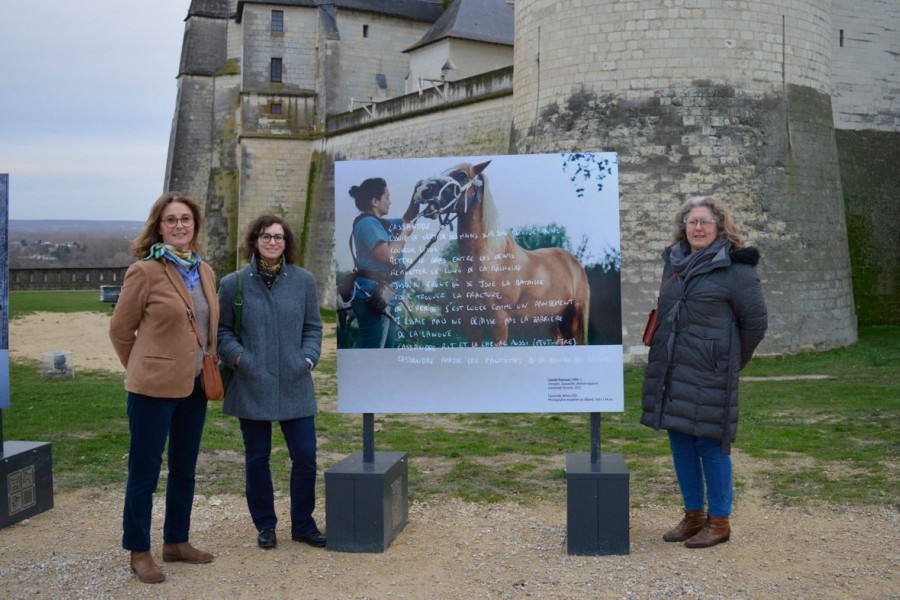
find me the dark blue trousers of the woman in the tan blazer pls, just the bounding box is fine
[122,377,206,552]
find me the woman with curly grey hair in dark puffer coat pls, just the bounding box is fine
[641,196,767,548]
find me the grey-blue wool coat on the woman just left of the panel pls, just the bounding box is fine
[218,259,322,421]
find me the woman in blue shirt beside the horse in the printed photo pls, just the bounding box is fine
[350,177,419,348]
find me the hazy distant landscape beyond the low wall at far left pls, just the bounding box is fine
[8,219,144,269]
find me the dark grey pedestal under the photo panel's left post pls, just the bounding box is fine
[325,452,409,552]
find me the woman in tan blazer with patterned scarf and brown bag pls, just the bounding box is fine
[109,192,219,583]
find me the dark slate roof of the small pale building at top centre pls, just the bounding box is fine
[404,0,515,52]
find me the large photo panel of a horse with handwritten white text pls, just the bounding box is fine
[335,153,624,413]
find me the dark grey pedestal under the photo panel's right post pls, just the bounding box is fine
[566,453,629,556]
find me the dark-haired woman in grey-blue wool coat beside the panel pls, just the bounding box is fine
[219,215,325,548]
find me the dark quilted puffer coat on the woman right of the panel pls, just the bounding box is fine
[641,245,768,454]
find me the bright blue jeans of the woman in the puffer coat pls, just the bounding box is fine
[669,430,734,517]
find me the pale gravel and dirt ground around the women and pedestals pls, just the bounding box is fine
[0,313,900,600]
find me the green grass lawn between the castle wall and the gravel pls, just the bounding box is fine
[3,292,900,507]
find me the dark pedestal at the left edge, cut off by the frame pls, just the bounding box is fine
[0,442,53,529]
